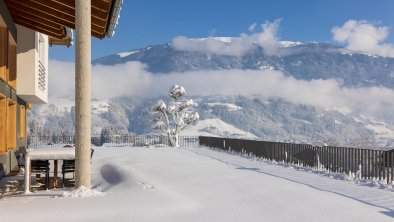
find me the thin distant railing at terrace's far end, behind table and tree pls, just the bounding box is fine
[27,135,199,148]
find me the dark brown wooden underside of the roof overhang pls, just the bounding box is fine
[5,0,112,39]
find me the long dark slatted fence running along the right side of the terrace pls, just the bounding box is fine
[199,136,394,184]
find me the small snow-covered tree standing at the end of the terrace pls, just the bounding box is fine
[153,85,200,147]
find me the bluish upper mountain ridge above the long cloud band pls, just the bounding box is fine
[93,38,394,88]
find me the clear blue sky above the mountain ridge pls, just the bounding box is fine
[49,0,394,61]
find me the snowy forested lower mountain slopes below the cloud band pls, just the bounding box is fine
[29,96,394,146]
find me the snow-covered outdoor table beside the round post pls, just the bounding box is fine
[25,147,75,193]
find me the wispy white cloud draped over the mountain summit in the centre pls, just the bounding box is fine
[172,19,281,57]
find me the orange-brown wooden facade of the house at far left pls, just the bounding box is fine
[0,1,27,177]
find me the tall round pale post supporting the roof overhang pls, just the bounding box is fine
[75,0,91,189]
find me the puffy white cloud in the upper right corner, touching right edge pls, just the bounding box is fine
[331,20,394,57]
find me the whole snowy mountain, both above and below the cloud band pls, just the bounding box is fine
[29,38,394,147]
